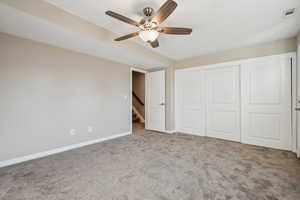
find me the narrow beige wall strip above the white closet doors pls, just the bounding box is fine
[176,38,297,69]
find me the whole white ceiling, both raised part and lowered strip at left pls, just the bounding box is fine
[0,0,300,69]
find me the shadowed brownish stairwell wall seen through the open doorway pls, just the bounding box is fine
[132,71,145,118]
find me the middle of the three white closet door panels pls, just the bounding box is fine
[205,66,241,142]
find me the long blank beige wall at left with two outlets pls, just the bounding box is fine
[0,33,131,161]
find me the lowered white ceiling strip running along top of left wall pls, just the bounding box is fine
[0,3,169,69]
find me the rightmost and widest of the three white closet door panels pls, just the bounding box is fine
[241,55,291,150]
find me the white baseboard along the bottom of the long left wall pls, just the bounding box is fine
[0,132,131,168]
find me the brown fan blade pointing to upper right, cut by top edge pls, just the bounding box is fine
[152,0,177,24]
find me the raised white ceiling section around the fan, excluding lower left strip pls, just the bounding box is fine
[47,0,300,60]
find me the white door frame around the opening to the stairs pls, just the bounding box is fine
[129,67,149,133]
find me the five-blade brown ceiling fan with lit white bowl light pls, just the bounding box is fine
[105,0,192,48]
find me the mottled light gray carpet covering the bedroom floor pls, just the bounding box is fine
[0,130,300,200]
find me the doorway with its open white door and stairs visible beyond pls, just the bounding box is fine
[130,68,166,135]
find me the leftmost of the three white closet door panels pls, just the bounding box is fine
[175,69,205,136]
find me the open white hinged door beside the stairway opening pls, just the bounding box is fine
[146,70,165,131]
